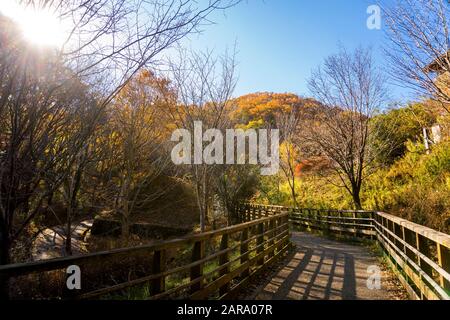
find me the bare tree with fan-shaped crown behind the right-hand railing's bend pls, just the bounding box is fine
[305,49,386,209]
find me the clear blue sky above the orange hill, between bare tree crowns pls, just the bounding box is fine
[184,0,412,100]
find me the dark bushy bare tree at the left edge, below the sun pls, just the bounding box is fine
[0,38,95,264]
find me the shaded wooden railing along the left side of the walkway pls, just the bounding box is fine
[0,212,290,299]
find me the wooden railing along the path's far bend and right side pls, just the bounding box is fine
[245,204,450,300]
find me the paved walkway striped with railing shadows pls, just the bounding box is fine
[249,232,393,300]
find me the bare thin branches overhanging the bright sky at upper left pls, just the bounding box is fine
[18,0,239,104]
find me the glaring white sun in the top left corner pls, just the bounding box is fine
[0,0,65,47]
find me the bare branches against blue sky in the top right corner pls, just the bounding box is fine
[383,0,450,112]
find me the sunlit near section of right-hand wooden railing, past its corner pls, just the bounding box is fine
[374,212,450,300]
